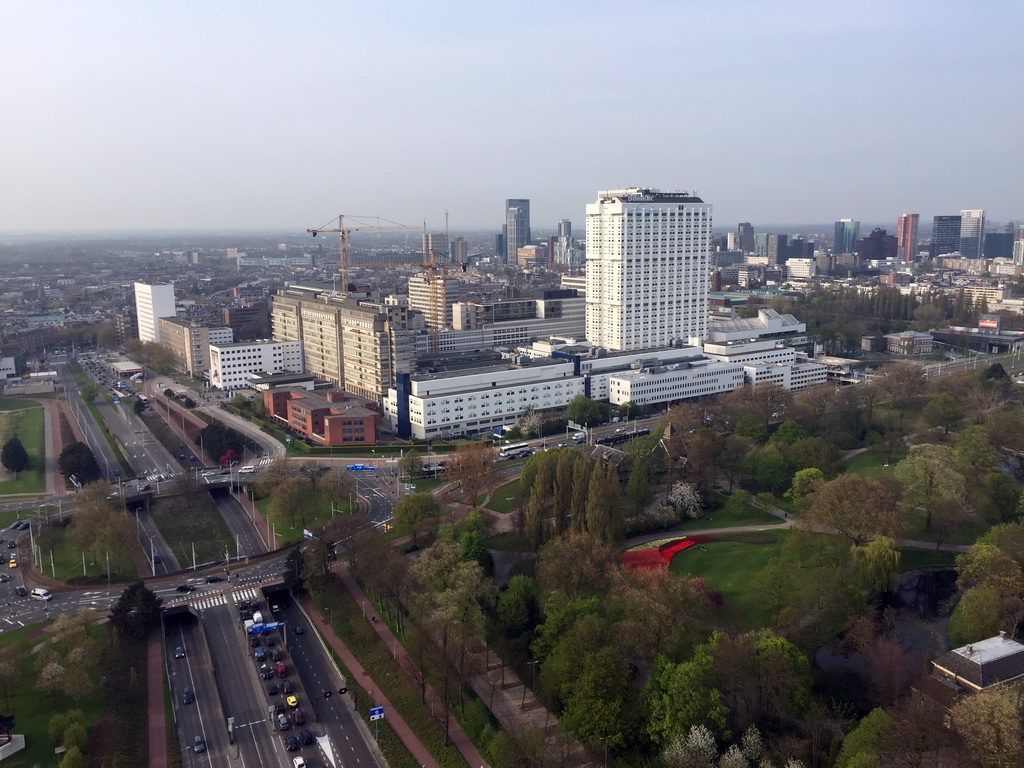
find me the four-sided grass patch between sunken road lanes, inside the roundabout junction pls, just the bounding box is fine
[151,490,234,568]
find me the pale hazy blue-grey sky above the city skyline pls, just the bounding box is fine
[0,0,1024,232]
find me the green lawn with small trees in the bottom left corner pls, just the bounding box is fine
[0,624,109,768]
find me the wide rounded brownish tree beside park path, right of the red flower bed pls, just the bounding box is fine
[802,474,904,547]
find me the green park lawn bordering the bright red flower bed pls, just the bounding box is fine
[669,530,790,632]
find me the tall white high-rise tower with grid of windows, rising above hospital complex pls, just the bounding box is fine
[587,187,712,350]
